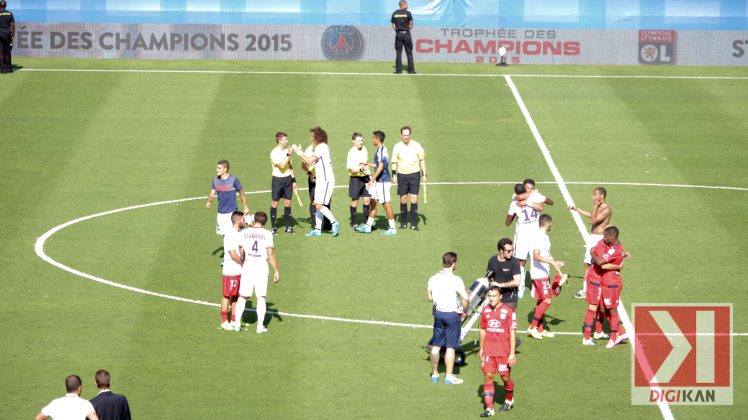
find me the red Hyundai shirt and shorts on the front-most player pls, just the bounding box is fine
[480,304,517,375]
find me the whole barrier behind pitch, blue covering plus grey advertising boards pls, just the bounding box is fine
[9,0,748,65]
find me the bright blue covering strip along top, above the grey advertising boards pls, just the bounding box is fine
[9,0,748,30]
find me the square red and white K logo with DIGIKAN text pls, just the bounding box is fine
[631,304,733,405]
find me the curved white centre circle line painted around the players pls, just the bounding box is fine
[34,181,748,337]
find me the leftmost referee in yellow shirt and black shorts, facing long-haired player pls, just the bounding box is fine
[270,131,297,235]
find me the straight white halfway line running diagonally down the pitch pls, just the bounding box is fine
[504,76,675,420]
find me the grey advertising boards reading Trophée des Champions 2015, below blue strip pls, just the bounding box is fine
[13,23,748,66]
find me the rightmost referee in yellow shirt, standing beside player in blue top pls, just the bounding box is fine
[392,126,428,230]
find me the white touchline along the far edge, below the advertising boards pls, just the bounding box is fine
[18,68,748,80]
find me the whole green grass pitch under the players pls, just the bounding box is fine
[0,58,748,419]
